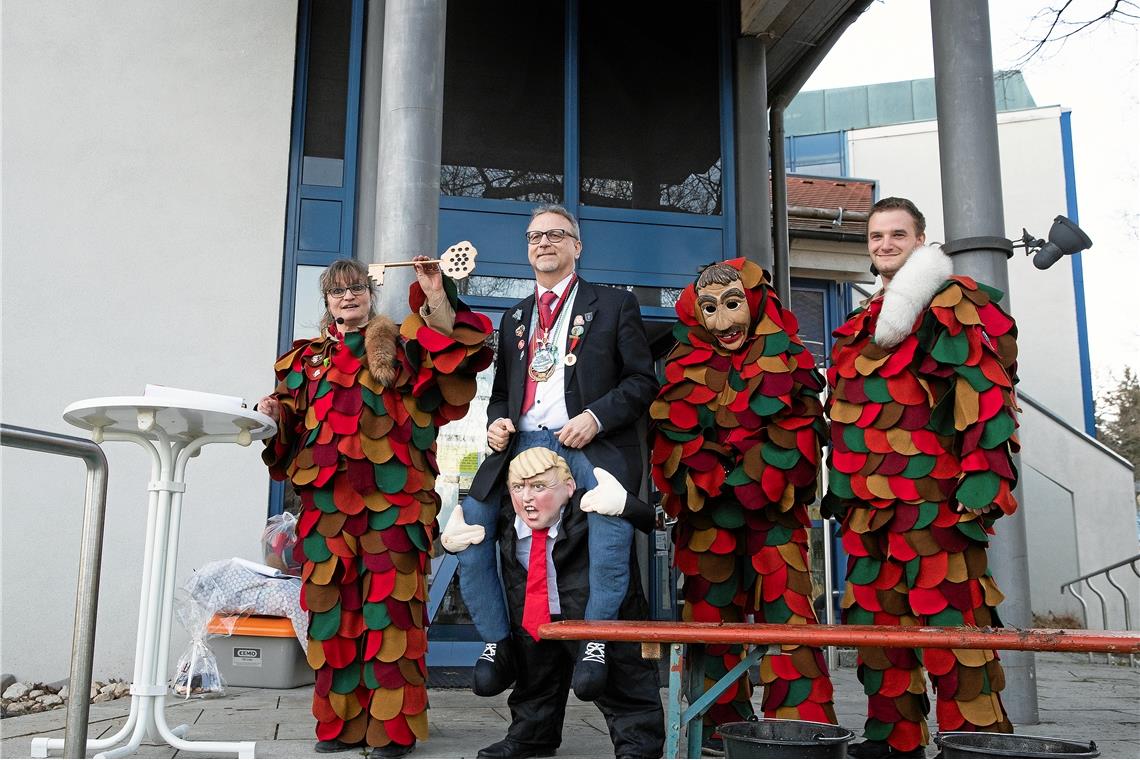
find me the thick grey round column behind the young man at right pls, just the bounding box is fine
[930,0,1039,725]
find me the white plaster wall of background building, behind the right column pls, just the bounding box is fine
[847,106,1084,430]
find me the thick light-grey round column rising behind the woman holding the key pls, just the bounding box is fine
[373,0,447,321]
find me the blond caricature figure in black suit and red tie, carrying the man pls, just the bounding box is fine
[465,447,665,758]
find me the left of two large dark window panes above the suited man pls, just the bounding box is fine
[440,0,565,202]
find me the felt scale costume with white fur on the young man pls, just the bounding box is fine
[824,248,1018,752]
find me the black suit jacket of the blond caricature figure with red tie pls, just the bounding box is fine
[498,489,653,628]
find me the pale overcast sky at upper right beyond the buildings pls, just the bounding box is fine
[804,0,1140,390]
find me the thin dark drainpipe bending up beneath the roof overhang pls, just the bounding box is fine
[768,0,871,308]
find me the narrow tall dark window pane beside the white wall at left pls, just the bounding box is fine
[301,0,352,187]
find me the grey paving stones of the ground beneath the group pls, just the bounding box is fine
[0,653,1140,760]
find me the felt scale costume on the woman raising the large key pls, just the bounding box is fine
[264,281,491,746]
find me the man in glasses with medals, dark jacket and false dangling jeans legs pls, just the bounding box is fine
[443,205,657,700]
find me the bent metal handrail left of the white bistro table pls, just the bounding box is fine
[0,423,107,758]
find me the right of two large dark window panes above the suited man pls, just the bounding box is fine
[579,2,720,214]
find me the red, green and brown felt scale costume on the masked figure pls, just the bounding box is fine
[650,259,836,735]
